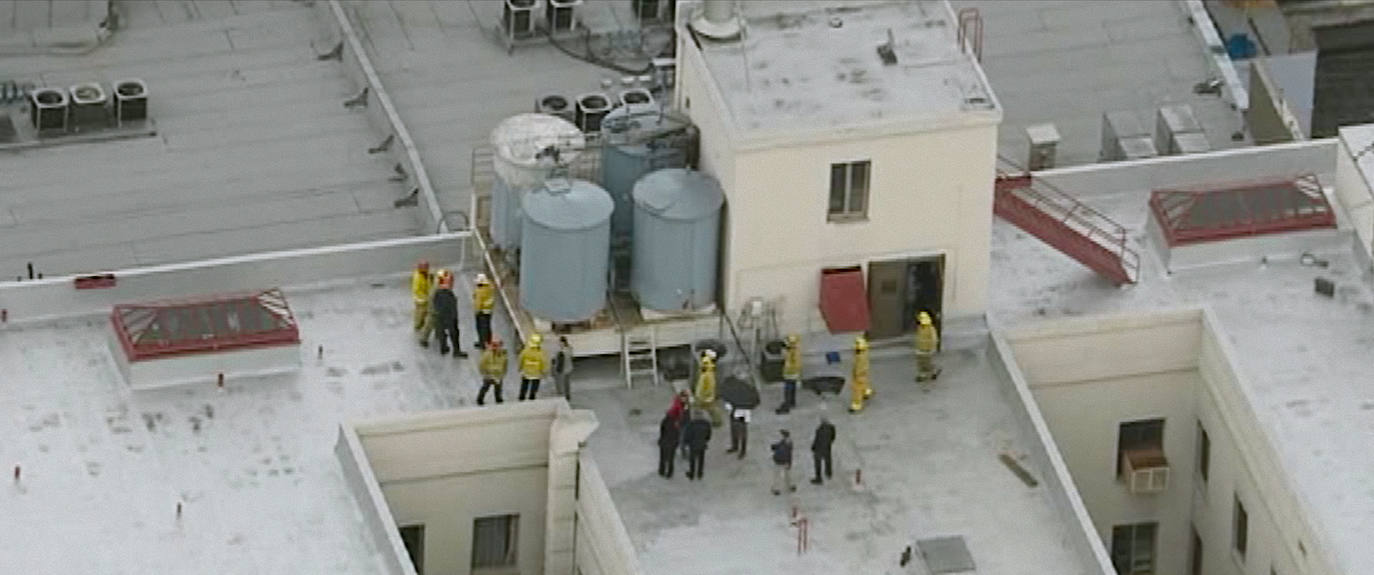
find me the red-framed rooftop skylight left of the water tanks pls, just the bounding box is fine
[110,289,301,362]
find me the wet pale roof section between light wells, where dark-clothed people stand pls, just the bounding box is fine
[585,351,1092,575]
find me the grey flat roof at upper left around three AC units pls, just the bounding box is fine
[0,0,416,279]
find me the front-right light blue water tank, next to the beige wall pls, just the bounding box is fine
[631,168,725,312]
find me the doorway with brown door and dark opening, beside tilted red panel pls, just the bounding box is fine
[868,254,944,338]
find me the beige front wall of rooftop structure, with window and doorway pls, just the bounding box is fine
[723,125,998,332]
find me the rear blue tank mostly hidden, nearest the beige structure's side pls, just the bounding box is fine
[602,103,687,241]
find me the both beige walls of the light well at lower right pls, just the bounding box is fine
[1004,310,1336,575]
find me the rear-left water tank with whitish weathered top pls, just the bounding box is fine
[491,114,587,252]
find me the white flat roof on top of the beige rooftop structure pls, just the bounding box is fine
[701,0,993,132]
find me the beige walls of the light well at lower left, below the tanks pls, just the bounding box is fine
[337,399,615,575]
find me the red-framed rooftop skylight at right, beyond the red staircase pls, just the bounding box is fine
[1150,173,1336,248]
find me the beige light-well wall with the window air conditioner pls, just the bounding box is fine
[1013,312,1201,575]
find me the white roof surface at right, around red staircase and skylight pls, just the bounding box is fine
[989,182,1374,574]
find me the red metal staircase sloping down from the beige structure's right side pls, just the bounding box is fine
[992,160,1140,286]
